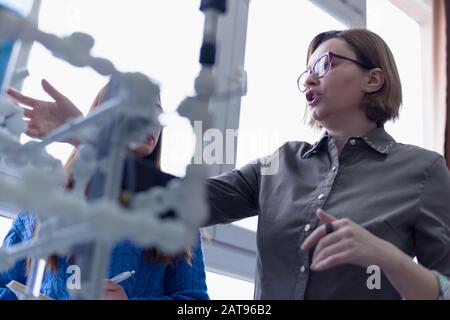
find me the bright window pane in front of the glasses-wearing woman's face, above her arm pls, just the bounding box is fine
[236,0,346,230]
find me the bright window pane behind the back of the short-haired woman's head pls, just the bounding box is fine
[367,0,427,147]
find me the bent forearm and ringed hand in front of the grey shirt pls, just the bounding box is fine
[302,209,439,299]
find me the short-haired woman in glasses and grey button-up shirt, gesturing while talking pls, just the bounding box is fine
[6,29,450,299]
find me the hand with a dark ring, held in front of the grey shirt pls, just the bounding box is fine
[302,209,392,271]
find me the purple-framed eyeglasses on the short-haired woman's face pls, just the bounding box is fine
[297,51,373,93]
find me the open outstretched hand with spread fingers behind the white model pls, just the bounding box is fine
[7,80,82,144]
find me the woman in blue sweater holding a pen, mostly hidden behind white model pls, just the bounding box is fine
[0,81,209,300]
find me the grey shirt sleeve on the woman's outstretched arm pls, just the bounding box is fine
[206,159,260,226]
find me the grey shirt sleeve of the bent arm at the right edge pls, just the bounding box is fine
[414,156,450,276]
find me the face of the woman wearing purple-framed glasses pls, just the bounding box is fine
[305,39,366,128]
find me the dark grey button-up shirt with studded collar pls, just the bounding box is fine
[208,128,450,299]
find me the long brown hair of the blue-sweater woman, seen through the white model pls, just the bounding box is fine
[32,85,192,272]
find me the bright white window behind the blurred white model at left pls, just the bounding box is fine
[23,0,204,176]
